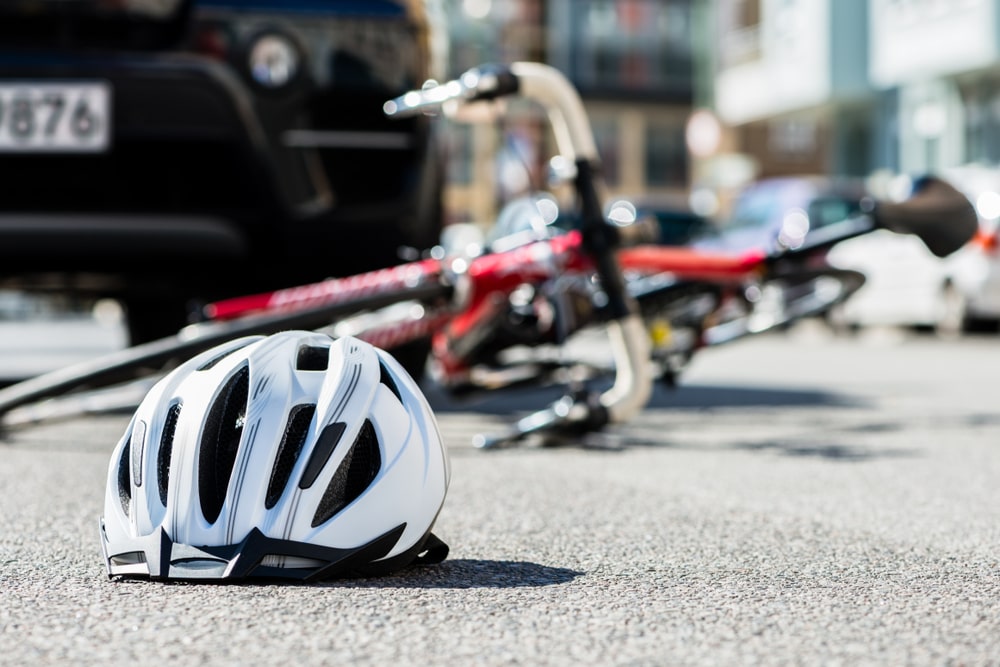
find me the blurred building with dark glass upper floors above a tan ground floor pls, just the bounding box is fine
[548,0,693,193]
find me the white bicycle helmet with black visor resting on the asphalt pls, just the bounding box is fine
[101,331,450,581]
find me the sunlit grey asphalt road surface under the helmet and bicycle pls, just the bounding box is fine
[0,328,1000,665]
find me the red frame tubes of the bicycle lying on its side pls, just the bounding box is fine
[204,231,766,377]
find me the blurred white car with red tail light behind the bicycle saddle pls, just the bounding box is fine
[827,172,1000,335]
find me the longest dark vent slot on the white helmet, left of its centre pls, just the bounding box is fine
[198,365,250,523]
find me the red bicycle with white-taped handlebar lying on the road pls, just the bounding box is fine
[0,63,975,447]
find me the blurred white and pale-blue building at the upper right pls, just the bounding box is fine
[710,0,1000,192]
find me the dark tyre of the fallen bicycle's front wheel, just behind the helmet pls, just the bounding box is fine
[0,283,451,426]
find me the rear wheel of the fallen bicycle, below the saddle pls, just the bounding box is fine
[702,268,865,345]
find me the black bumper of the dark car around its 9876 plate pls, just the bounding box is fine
[0,50,442,282]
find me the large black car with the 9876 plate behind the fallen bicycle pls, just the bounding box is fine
[0,0,447,342]
